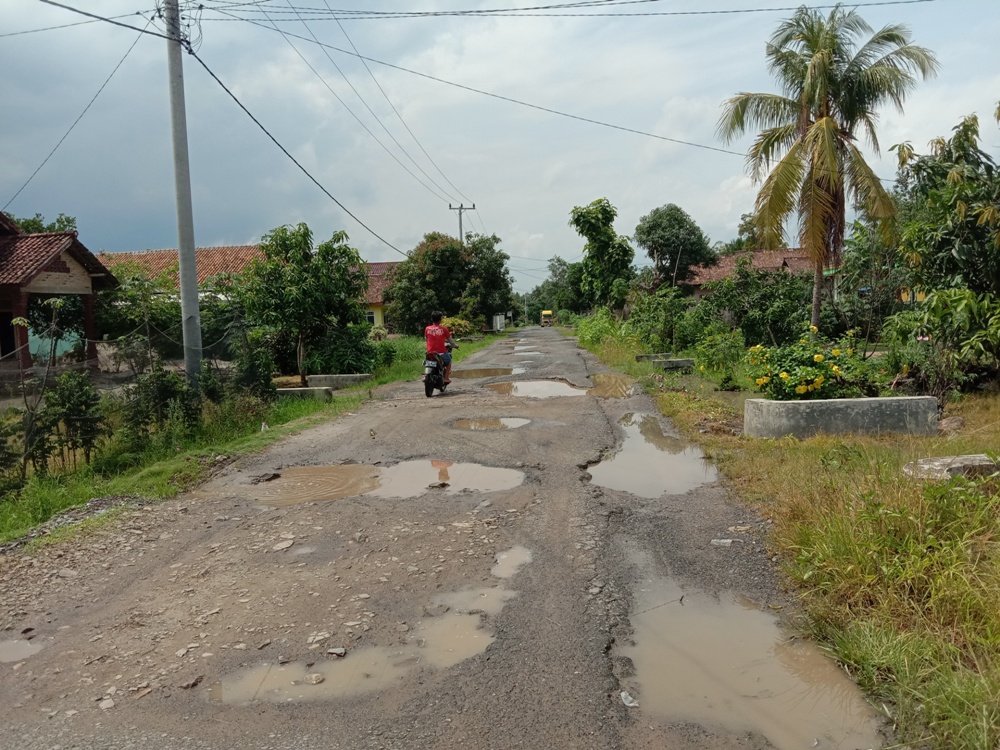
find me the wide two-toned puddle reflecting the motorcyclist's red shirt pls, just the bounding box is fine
[251,460,524,507]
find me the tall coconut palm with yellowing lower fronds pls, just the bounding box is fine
[718,5,937,326]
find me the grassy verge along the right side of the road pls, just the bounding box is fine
[593,334,1000,750]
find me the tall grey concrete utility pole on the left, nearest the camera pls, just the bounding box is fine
[163,0,201,386]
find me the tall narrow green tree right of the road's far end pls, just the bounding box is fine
[569,198,635,308]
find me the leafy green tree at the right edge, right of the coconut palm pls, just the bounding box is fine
[895,115,1000,295]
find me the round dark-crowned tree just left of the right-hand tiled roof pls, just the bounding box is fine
[633,203,718,286]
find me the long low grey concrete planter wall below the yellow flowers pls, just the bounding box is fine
[743,396,938,438]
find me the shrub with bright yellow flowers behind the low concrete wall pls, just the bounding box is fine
[746,326,884,401]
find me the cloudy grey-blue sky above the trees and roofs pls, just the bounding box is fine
[0,0,1000,291]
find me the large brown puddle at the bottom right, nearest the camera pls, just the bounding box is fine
[623,580,883,750]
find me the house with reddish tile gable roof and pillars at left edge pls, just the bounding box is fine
[0,212,118,371]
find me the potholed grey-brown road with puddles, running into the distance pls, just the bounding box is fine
[0,329,892,750]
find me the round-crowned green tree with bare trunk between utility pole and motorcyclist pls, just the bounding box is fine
[240,223,368,386]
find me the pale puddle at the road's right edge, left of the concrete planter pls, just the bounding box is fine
[588,414,717,498]
